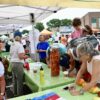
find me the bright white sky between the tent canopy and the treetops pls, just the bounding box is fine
[42,8,100,26]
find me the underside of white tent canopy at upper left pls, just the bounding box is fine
[0,5,61,31]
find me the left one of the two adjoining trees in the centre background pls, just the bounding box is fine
[47,19,61,28]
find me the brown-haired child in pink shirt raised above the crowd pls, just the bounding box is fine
[71,18,82,39]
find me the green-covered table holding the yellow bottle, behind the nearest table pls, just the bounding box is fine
[24,63,75,92]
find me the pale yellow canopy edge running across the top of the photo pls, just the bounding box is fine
[0,0,100,8]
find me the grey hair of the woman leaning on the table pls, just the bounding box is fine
[77,42,99,57]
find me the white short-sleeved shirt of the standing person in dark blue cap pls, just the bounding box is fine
[10,41,25,63]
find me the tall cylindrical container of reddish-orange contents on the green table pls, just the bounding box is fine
[50,48,60,76]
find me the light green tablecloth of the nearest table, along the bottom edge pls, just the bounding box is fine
[9,85,97,100]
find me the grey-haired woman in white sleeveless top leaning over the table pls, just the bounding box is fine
[72,42,100,95]
